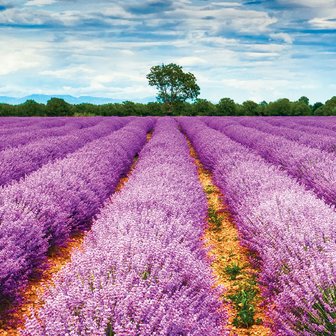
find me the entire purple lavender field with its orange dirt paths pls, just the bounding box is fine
[0,117,336,336]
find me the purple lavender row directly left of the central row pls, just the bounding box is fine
[0,119,153,301]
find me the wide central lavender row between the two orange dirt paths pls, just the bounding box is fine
[24,119,227,336]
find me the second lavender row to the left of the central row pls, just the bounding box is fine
[0,118,127,185]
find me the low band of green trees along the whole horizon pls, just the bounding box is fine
[0,96,336,116]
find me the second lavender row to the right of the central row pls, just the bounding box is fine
[205,117,336,205]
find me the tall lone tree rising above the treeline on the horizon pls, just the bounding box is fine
[147,63,200,113]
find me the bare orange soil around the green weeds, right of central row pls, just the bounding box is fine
[188,141,272,336]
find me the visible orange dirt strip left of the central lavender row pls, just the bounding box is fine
[0,132,152,336]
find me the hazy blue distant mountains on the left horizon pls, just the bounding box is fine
[0,94,155,105]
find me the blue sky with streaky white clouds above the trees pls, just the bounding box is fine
[0,0,336,102]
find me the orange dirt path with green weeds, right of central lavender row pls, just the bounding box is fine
[188,140,272,336]
